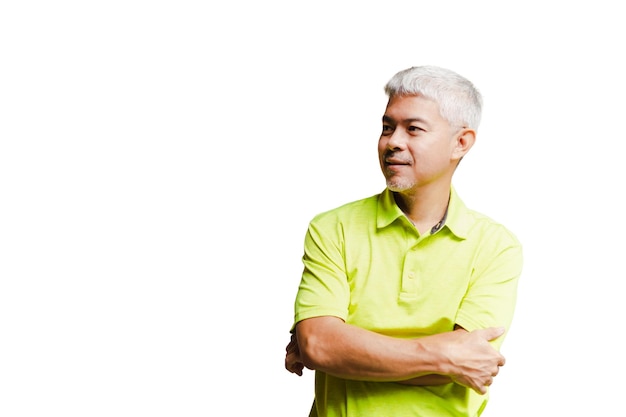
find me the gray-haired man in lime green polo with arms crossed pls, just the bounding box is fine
[285,66,522,417]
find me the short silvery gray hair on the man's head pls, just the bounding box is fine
[385,66,482,130]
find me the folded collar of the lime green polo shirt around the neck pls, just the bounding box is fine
[376,187,471,239]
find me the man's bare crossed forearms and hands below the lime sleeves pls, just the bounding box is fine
[285,316,505,394]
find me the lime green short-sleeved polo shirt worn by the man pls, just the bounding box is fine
[294,189,522,417]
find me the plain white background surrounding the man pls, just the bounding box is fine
[0,1,626,417]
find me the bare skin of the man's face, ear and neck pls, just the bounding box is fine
[378,92,476,233]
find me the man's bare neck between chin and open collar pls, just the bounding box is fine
[393,184,450,233]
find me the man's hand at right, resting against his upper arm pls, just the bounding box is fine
[436,327,505,394]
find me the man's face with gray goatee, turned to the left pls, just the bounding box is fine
[378,96,471,192]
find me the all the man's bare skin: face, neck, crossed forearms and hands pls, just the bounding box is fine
[285,96,505,394]
